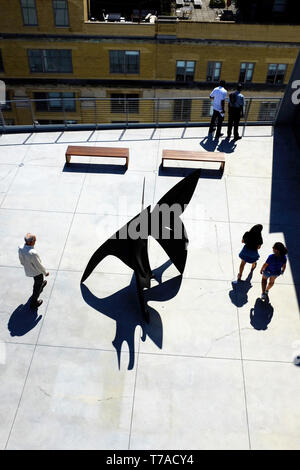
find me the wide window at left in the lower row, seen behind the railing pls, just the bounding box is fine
[33,92,76,112]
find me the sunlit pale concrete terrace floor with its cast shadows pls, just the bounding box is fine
[0,127,300,450]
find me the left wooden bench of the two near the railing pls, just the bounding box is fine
[66,145,129,169]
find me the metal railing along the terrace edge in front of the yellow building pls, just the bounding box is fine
[0,96,281,133]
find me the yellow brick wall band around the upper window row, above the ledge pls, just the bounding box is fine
[1,40,298,83]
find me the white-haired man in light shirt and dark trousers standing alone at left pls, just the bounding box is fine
[19,233,49,308]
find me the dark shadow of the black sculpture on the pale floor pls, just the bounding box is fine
[80,260,182,370]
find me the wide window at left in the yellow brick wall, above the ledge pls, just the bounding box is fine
[28,49,72,73]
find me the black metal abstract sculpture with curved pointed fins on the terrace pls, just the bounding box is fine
[81,170,201,323]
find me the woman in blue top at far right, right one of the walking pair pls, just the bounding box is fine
[260,242,288,299]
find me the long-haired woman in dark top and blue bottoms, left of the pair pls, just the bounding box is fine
[237,224,263,281]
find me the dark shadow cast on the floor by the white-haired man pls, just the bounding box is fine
[7,297,42,336]
